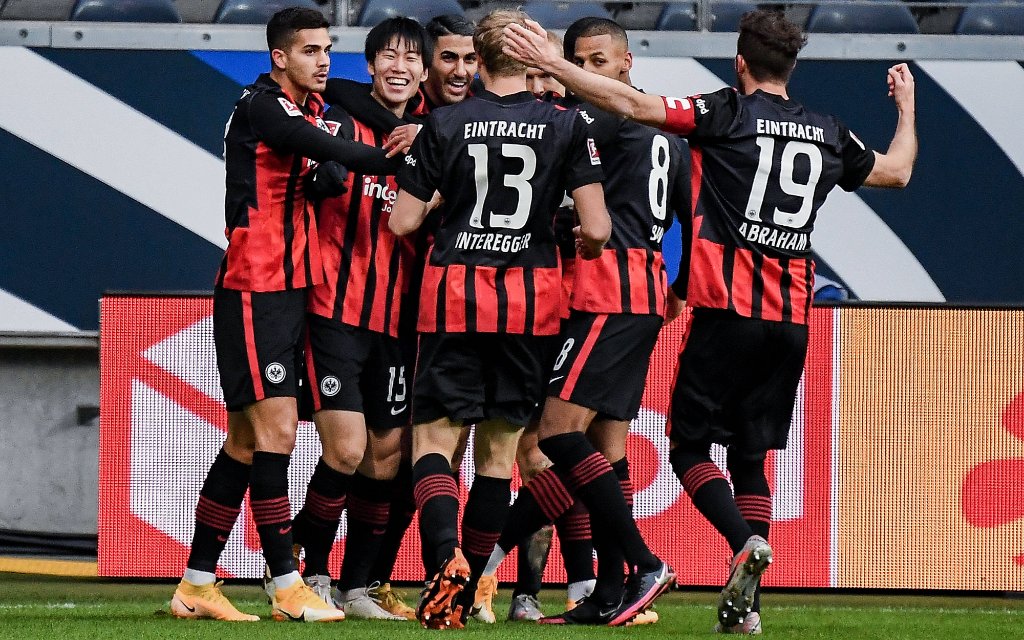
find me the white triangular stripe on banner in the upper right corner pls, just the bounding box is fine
[918,60,1024,174]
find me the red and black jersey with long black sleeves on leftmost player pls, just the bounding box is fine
[216,74,401,291]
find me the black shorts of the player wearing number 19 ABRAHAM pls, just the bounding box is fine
[669,309,807,458]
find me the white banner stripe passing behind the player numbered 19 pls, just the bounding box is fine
[632,57,942,301]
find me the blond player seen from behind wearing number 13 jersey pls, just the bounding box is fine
[390,11,610,628]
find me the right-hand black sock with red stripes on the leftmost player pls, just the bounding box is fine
[249,452,295,578]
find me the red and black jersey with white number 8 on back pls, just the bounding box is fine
[561,93,689,315]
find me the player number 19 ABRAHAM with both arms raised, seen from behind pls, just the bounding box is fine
[506,10,918,633]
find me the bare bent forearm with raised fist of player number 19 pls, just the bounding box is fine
[864,62,918,188]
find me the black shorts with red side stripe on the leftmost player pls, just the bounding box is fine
[213,287,306,412]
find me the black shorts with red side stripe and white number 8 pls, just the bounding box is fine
[548,309,665,421]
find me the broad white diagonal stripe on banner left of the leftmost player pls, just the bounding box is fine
[0,47,227,248]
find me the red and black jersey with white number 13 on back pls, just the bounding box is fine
[398,91,603,335]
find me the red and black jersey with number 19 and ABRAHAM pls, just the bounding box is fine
[664,88,874,324]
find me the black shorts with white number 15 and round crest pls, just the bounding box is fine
[306,313,413,429]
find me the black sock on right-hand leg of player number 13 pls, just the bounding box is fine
[462,475,512,605]
